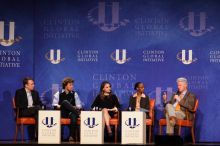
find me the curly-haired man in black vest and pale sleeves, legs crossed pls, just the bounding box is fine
[52,77,82,141]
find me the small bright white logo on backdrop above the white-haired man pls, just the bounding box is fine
[176,50,198,65]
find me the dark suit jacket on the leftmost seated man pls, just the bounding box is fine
[15,88,42,109]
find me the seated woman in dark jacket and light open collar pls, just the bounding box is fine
[129,82,150,118]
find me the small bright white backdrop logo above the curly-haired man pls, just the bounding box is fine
[45,49,65,64]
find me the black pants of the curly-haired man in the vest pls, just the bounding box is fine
[61,100,79,138]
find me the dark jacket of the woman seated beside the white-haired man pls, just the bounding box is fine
[129,94,150,118]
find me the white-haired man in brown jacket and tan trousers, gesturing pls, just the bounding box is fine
[163,77,196,135]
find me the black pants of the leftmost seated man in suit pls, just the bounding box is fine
[19,106,41,138]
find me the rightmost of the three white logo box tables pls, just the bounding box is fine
[121,111,146,144]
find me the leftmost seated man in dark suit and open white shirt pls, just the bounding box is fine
[15,77,43,139]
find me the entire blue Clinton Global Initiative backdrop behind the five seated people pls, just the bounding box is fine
[0,0,220,142]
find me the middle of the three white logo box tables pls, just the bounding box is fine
[80,111,105,144]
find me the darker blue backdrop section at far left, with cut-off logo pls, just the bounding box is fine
[0,0,34,140]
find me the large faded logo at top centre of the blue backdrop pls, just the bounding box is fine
[88,2,130,32]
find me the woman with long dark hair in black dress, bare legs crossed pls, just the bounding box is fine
[91,81,119,136]
